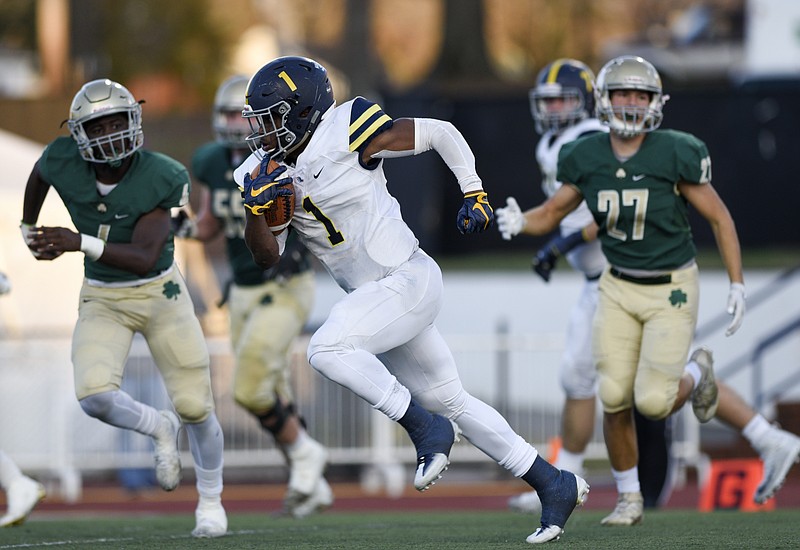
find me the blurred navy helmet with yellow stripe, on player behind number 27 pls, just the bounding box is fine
[528,59,594,134]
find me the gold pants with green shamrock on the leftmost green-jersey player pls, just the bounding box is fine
[72,266,214,422]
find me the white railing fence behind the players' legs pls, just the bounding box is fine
[0,332,699,501]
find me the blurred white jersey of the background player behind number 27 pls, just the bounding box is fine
[536,118,608,233]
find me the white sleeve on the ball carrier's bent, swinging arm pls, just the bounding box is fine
[414,118,483,194]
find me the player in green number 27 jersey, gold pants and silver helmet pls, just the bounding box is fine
[498,56,800,526]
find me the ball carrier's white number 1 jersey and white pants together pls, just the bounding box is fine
[234,97,537,477]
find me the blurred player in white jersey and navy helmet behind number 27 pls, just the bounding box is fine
[495,59,669,514]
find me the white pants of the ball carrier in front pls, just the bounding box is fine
[308,250,537,477]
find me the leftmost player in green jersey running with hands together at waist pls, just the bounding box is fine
[21,79,228,538]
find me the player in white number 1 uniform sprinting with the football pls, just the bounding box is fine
[234,57,589,543]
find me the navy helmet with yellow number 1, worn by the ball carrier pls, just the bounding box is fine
[242,56,335,158]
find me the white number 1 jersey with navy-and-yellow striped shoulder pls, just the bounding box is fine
[234,101,419,293]
